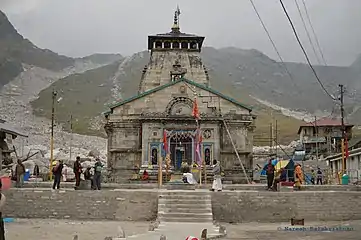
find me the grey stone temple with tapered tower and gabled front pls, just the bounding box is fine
[105,9,255,182]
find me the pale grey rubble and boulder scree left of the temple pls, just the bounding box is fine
[0,65,106,172]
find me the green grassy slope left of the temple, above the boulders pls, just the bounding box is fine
[31,61,119,134]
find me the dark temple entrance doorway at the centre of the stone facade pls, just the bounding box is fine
[170,131,194,170]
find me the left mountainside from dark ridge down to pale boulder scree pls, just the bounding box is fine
[0,9,123,168]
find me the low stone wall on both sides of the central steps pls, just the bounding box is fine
[2,186,361,222]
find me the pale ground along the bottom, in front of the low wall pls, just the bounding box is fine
[6,219,361,240]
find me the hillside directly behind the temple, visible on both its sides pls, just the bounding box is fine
[32,48,359,144]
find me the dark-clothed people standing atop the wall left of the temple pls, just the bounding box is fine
[52,156,103,190]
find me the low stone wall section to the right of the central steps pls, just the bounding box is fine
[212,191,361,225]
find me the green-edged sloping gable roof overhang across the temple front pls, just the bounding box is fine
[103,78,252,116]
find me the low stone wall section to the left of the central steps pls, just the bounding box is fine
[2,188,158,221]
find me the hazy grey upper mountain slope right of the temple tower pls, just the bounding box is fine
[203,48,356,112]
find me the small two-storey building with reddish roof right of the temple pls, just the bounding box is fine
[298,118,353,155]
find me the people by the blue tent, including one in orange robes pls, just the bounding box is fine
[266,159,304,191]
